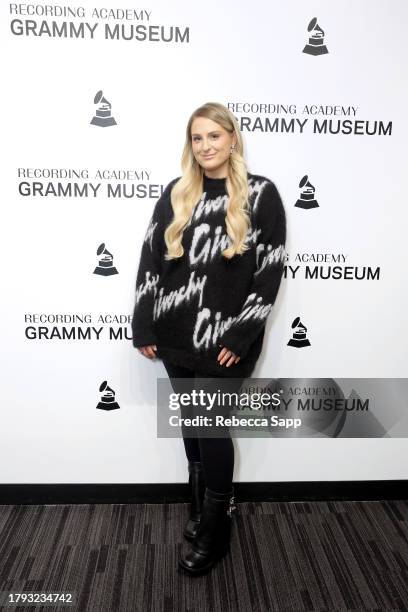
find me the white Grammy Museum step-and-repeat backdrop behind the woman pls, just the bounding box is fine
[0,0,408,483]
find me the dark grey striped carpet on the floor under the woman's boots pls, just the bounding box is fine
[0,501,408,612]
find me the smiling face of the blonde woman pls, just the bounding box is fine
[191,117,236,178]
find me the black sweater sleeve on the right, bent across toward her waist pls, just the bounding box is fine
[218,180,286,359]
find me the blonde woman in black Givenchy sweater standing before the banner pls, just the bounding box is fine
[132,103,286,575]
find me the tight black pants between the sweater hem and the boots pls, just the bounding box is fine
[163,360,244,493]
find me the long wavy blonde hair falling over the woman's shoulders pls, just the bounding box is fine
[164,102,250,260]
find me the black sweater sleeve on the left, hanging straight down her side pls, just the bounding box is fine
[132,179,178,348]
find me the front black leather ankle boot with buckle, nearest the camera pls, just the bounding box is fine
[179,488,235,576]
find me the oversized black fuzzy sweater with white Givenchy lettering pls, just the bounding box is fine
[132,173,286,377]
